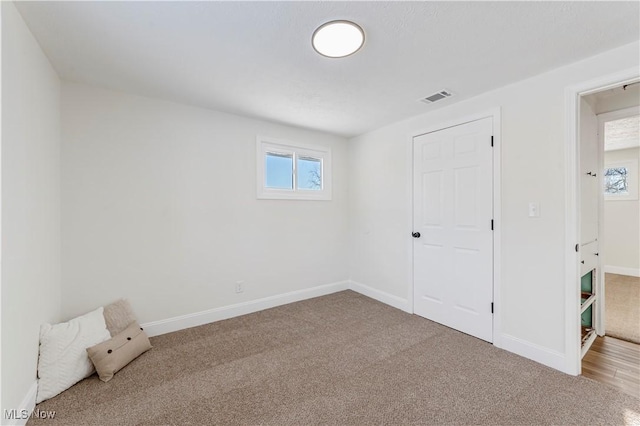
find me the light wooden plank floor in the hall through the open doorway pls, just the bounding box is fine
[582,336,640,398]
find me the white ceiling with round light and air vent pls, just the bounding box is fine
[17,1,640,136]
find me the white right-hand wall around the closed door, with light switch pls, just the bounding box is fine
[349,42,640,368]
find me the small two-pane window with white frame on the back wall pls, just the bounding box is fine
[257,136,331,200]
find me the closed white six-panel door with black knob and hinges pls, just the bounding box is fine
[413,118,493,342]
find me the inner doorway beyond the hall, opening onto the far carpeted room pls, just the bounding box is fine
[596,88,640,344]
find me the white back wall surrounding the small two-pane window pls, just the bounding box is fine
[62,83,348,322]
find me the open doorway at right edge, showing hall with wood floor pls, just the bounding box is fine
[579,81,640,395]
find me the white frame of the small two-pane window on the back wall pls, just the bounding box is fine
[256,136,332,200]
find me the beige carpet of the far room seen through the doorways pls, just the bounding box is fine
[604,274,640,343]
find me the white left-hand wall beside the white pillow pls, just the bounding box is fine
[1,2,60,413]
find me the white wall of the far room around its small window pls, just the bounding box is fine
[604,148,640,273]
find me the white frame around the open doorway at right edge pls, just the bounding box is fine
[564,68,640,375]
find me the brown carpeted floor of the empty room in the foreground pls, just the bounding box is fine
[29,291,640,425]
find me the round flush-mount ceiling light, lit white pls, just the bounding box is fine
[311,21,364,58]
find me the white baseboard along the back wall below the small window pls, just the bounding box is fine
[141,281,349,336]
